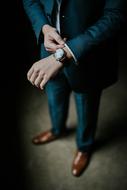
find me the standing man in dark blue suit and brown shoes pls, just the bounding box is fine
[23,0,125,176]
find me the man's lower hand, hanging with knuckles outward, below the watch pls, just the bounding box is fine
[27,55,63,89]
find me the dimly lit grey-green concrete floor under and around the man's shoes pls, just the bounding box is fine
[18,42,127,190]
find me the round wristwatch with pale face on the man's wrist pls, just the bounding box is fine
[53,48,66,63]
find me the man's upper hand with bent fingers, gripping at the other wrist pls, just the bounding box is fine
[42,24,65,53]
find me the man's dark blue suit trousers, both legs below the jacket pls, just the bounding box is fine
[46,72,101,151]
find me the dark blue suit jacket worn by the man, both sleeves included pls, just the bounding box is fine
[23,0,126,92]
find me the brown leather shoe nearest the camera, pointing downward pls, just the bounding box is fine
[72,151,90,177]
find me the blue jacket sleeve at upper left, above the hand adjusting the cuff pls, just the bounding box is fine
[23,0,49,42]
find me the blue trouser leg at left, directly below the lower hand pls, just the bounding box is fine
[46,72,71,135]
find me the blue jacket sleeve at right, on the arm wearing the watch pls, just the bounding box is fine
[66,0,126,61]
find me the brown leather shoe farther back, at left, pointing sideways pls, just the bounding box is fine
[32,130,58,145]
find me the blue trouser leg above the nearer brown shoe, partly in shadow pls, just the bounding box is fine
[75,90,101,151]
